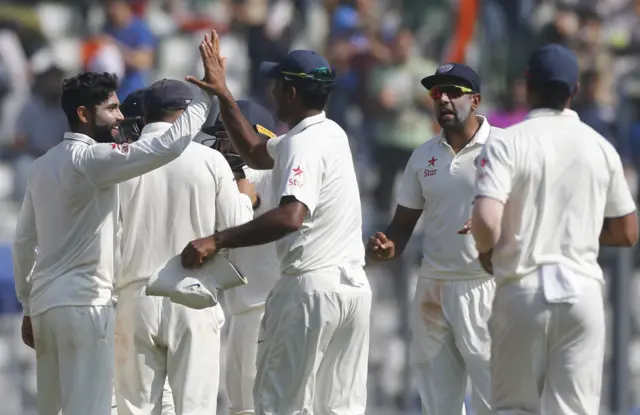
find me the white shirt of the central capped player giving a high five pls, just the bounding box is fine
[267,112,364,276]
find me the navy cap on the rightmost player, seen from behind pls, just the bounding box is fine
[527,43,580,91]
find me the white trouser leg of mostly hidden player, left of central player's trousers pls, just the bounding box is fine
[226,306,264,415]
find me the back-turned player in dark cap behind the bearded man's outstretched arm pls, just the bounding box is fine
[115,79,255,415]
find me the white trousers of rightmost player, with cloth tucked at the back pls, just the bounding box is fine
[490,273,605,415]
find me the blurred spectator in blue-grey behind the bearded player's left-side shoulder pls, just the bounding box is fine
[13,66,69,201]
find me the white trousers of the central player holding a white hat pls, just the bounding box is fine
[253,268,371,415]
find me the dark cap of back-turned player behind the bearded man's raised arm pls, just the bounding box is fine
[142,79,193,114]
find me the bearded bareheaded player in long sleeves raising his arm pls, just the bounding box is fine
[14,36,218,415]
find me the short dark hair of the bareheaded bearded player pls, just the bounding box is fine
[60,72,118,127]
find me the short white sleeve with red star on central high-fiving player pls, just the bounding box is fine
[275,137,324,214]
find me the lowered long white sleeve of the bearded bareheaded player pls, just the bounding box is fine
[13,185,38,316]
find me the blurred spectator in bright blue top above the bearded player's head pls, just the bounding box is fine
[103,0,156,101]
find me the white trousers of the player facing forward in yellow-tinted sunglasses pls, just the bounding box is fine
[410,278,495,415]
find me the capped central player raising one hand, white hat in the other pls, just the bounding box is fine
[182,31,371,415]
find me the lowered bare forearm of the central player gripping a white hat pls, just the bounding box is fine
[214,207,300,249]
